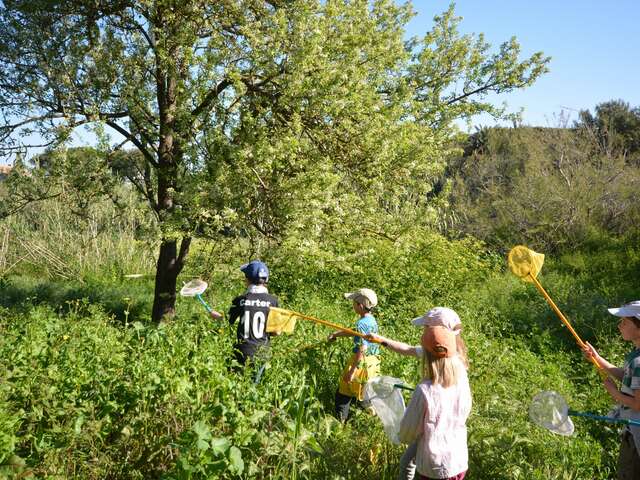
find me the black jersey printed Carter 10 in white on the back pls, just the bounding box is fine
[229,286,278,355]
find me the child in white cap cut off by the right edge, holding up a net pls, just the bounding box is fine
[583,300,640,480]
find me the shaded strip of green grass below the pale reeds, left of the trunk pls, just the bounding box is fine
[0,277,153,323]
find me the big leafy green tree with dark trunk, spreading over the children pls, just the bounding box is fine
[0,0,548,321]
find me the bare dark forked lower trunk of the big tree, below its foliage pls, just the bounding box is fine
[151,237,191,323]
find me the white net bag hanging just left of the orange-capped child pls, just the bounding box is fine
[364,376,405,445]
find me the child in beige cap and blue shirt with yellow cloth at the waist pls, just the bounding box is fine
[328,288,380,422]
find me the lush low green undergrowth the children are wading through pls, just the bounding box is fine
[0,232,638,480]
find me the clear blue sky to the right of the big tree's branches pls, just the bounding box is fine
[407,0,640,126]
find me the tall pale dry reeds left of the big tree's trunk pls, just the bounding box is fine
[0,189,156,281]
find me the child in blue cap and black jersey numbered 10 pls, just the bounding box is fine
[211,260,278,365]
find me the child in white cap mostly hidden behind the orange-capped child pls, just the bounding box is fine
[370,307,469,480]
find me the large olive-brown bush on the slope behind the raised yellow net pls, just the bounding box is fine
[448,127,640,252]
